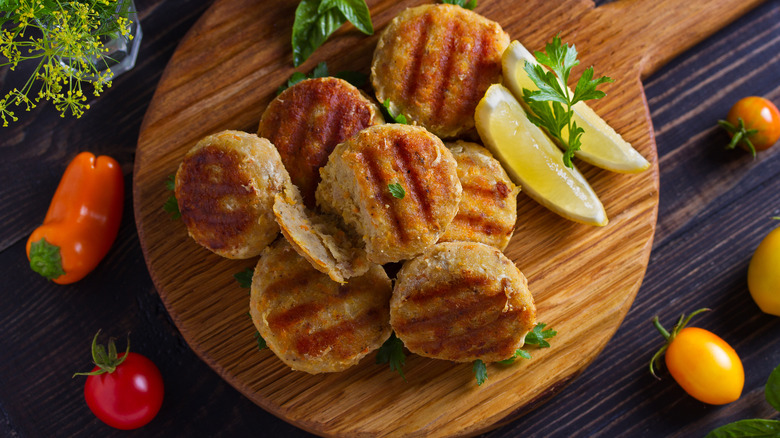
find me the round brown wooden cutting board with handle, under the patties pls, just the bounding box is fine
[133,0,760,437]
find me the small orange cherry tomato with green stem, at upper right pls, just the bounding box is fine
[721,96,780,151]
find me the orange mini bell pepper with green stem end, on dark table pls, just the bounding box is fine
[27,152,125,284]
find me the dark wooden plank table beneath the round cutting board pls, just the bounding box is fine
[0,0,780,437]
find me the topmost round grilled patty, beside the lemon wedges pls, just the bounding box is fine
[371,4,509,138]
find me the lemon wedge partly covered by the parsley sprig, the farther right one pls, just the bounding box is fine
[502,41,650,173]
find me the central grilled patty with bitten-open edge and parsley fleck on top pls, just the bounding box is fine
[316,124,461,264]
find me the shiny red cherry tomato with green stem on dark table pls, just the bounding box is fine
[76,332,164,430]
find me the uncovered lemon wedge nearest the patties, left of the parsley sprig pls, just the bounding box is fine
[474,84,607,226]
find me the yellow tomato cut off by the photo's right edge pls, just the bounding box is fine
[748,228,780,316]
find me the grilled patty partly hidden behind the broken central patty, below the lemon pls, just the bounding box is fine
[439,141,520,250]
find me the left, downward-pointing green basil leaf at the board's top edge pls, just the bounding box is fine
[292,0,347,67]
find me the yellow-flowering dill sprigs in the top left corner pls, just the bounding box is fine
[0,0,134,126]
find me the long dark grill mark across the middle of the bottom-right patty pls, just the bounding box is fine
[394,289,511,333]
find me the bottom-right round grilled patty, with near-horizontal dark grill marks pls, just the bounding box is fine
[390,242,536,362]
